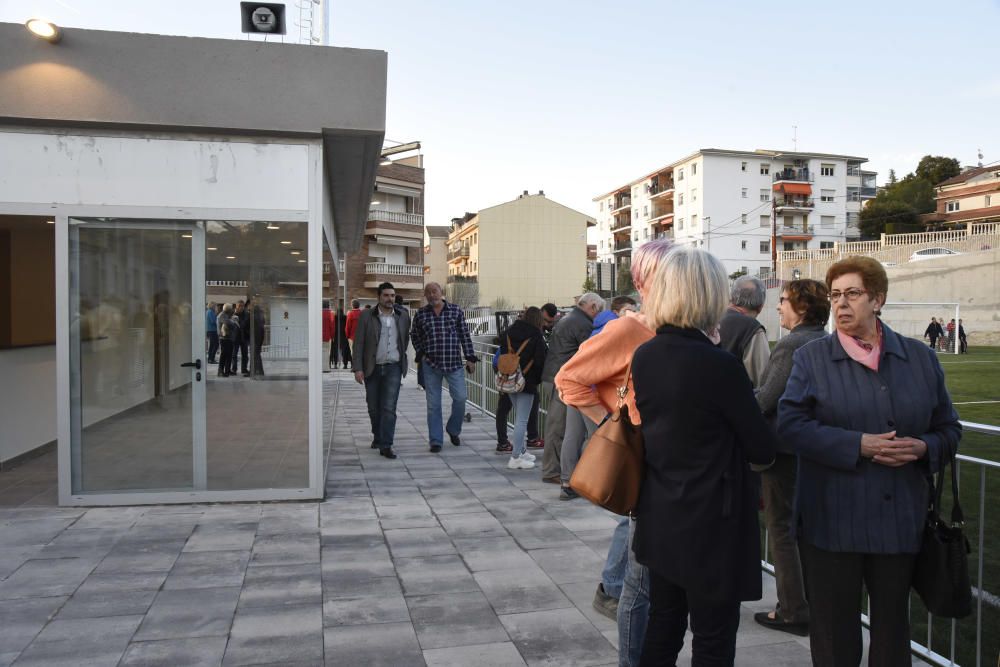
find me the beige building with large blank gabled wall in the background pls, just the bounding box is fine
[447,190,595,308]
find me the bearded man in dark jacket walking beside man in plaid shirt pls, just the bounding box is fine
[352,283,410,459]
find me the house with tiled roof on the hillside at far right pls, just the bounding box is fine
[921,165,1000,229]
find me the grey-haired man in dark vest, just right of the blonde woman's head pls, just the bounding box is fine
[719,276,771,388]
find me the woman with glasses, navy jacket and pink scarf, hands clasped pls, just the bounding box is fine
[778,257,961,667]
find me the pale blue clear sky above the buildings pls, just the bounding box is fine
[0,0,1000,225]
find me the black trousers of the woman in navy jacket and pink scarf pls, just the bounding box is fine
[799,540,916,667]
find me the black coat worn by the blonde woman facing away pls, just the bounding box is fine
[632,325,775,604]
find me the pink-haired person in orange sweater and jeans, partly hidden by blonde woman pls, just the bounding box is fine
[555,239,674,665]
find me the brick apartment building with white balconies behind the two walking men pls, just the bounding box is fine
[332,155,425,305]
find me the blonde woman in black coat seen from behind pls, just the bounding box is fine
[632,248,775,665]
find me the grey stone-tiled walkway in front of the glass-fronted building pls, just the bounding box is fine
[0,372,809,667]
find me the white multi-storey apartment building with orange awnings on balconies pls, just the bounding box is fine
[591,148,876,275]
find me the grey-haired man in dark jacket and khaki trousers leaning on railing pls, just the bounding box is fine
[542,292,604,490]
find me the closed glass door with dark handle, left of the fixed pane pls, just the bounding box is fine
[69,219,207,495]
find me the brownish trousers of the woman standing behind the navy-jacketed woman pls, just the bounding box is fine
[760,453,809,623]
